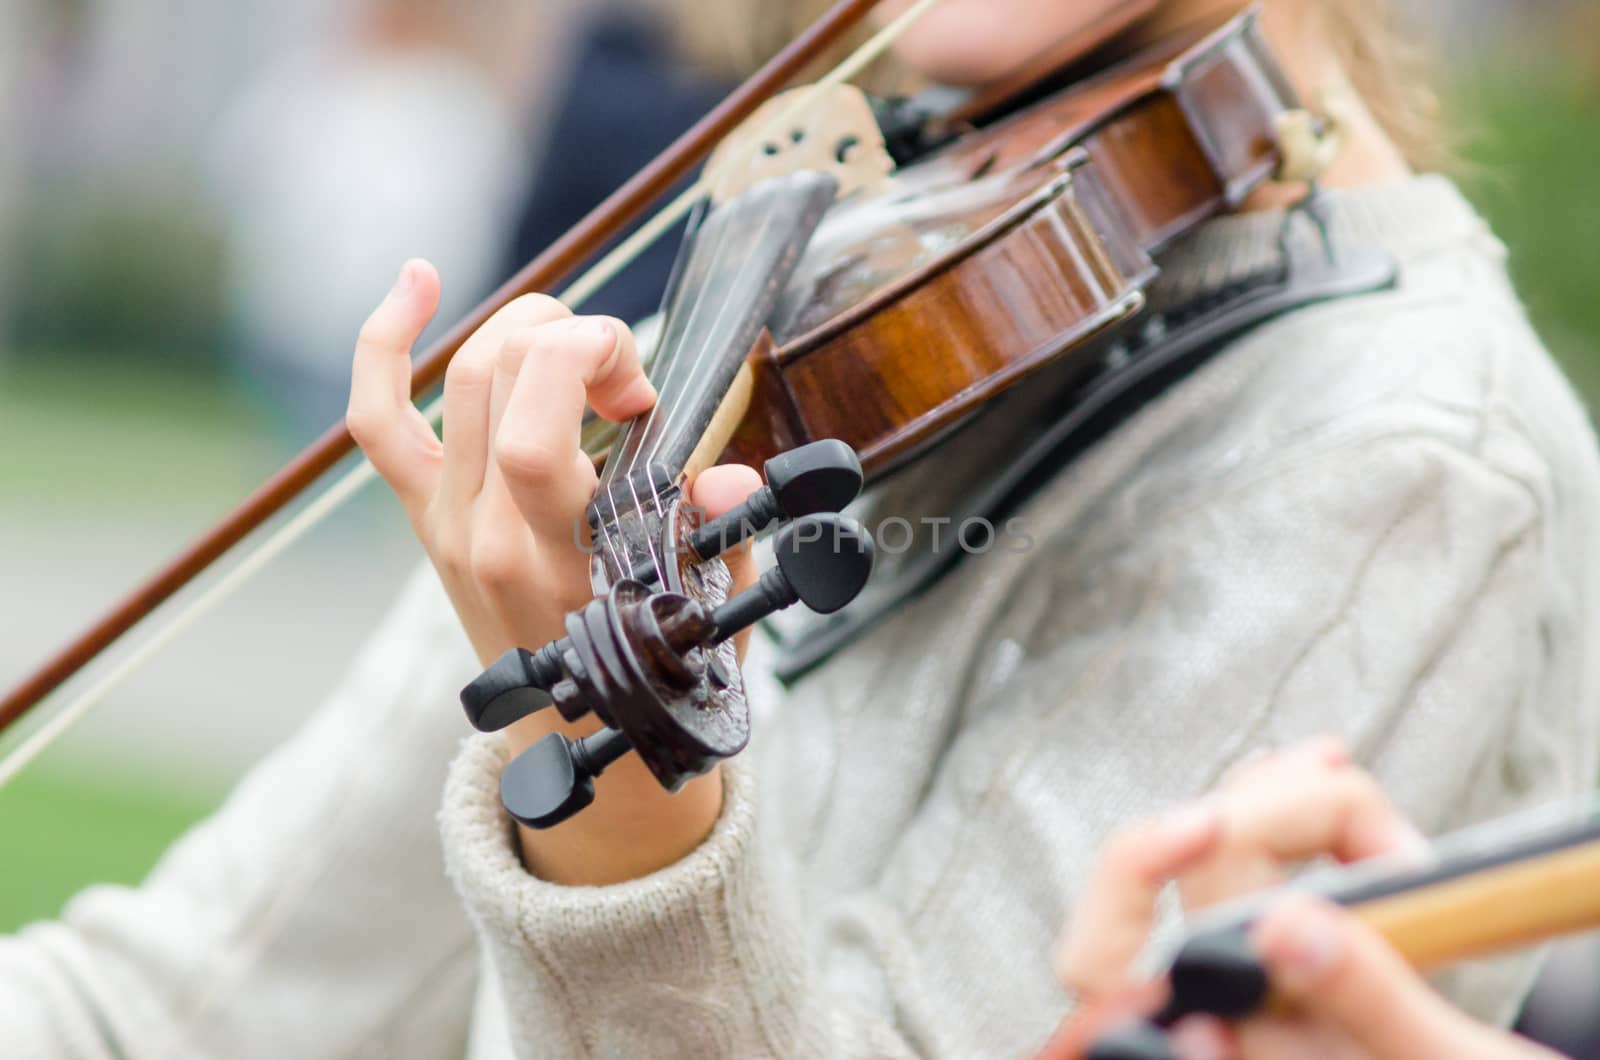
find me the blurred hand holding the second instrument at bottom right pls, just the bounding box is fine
[1042,740,1552,1060]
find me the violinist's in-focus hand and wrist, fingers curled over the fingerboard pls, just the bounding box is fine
[346,261,760,882]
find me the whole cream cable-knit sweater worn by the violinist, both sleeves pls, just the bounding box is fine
[0,178,1600,1060]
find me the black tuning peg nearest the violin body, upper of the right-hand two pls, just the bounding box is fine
[634,439,862,581]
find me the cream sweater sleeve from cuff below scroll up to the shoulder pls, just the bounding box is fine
[445,178,1600,1057]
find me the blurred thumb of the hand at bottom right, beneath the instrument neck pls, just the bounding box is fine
[1253,895,1523,1060]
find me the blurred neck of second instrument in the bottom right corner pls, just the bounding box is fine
[1088,801,1600,1060]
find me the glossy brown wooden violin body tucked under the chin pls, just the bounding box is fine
[720,11,1296,479]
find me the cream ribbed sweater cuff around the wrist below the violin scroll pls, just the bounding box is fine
[442,737,805,1055]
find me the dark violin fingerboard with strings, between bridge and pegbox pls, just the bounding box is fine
[594,171,838,519]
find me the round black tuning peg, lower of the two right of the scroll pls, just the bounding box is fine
[710,514,874,642]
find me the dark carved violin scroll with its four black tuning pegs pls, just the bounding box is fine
[461,440,874,828]
